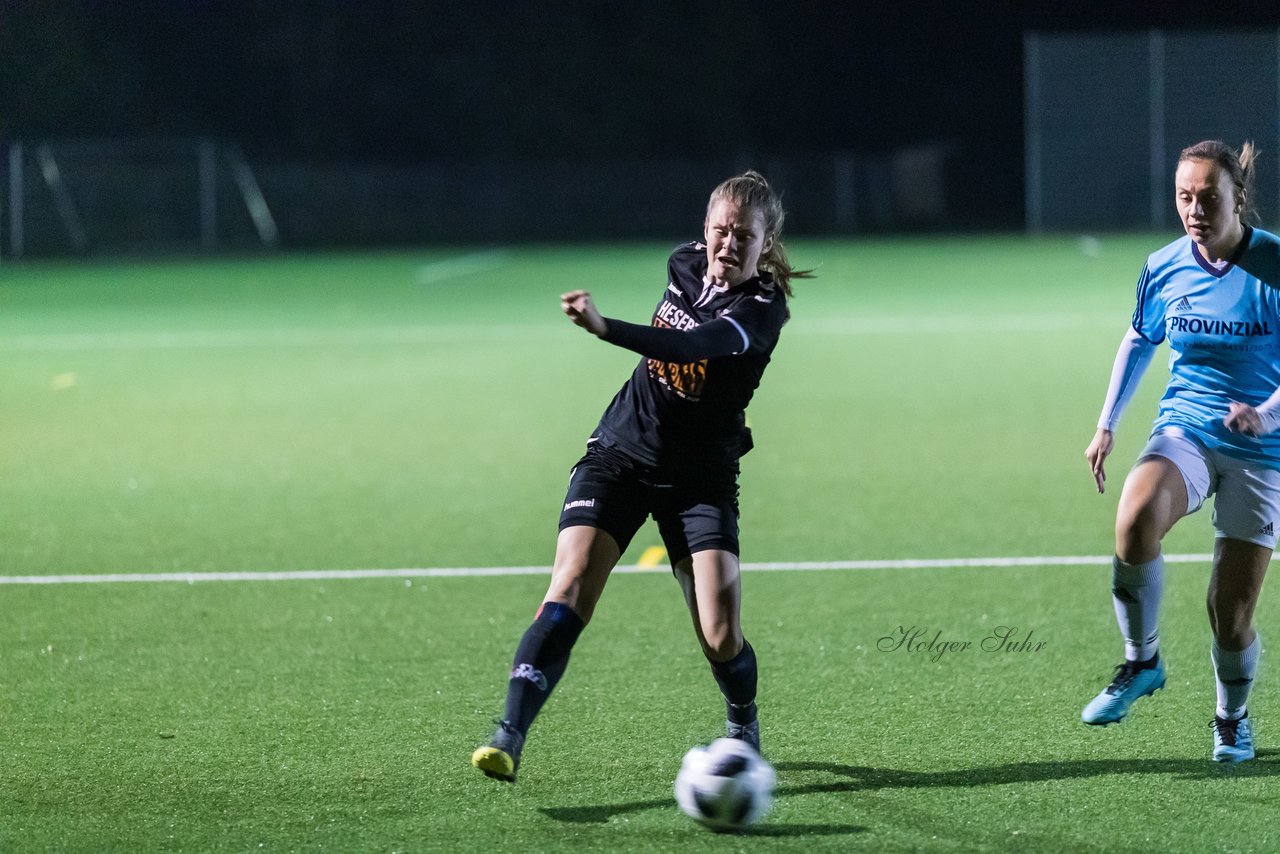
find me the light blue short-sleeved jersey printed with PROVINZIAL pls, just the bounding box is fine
[1133,228,1280,469]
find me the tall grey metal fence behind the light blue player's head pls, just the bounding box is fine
[1024,29,1280,232]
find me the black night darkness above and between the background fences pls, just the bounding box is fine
[0,0,1280,240]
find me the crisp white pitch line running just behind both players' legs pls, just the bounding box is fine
[0,554,1213,585]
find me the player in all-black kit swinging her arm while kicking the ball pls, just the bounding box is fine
[471,172,809,782]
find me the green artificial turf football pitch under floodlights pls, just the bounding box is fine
[0,237,1280,851]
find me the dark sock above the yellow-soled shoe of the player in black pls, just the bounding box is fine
[502,602,584,734]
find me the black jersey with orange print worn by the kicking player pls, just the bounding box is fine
[593,243,788,472]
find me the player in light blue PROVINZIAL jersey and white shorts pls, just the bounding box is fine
[1082,141,1280,762]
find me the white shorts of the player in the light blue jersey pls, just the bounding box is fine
[1138,428,1280,549]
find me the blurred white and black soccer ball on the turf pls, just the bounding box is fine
[676,739,774,832]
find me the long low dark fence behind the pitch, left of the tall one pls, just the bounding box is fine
[0,140,966,257]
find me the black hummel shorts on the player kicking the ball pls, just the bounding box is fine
[559,443,739,566]
